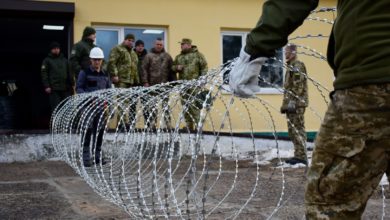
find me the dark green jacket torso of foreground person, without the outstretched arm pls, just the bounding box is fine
[328,0,390,89]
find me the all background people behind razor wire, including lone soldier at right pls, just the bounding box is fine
[41,27,308,167]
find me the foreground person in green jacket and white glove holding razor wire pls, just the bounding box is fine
[230,0,390,220]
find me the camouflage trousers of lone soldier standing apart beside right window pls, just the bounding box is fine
[286,108,307,160]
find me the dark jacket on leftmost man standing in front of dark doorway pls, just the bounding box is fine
[41,53,73,91]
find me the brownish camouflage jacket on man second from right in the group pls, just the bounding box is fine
[141,49,176,85]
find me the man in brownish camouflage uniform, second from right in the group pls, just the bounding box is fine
[141,38,176,129]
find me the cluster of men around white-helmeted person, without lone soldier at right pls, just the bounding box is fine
[41,27,208,167]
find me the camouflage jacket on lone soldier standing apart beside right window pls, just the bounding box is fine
[282,60,309,108]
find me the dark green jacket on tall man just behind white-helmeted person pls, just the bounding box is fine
[69,38,95,79]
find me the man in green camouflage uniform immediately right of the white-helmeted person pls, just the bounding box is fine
[107,34,140,126]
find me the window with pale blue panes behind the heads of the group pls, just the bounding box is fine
[95,26,166,60]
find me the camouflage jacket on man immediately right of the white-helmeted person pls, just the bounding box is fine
[107,44,140,85]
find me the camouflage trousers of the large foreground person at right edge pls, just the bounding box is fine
[305,84,390,219]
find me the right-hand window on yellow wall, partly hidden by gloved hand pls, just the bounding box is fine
[221,31,284,94]
